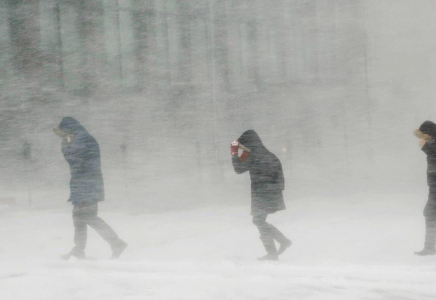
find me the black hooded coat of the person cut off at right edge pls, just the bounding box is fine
[419,121,436,218]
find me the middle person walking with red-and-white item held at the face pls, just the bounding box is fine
[231,130,292,260]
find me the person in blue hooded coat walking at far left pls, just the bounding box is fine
[54,117,127,259]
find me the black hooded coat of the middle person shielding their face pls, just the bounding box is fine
[232,130,286,216]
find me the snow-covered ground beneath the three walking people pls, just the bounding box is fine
[0,195,436,300]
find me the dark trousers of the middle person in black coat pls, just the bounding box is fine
[253,214,288,254]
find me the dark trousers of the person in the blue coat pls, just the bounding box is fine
[73,203,121,251]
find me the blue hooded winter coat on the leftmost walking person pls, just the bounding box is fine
[59,117,104,205]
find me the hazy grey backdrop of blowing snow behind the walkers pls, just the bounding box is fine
[0,0,436,211]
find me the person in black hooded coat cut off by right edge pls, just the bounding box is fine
[414,121,436,256]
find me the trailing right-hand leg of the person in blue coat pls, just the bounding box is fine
[87,204,127,258]
